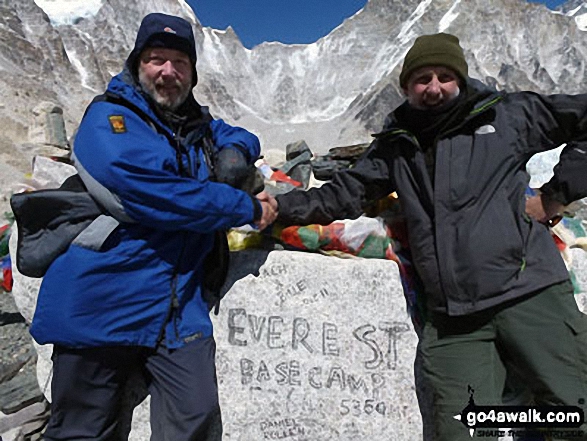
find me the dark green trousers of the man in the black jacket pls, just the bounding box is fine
[420,282,587,441]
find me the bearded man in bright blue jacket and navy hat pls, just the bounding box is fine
[31,14,275,441]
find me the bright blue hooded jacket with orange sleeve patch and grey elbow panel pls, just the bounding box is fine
[31,71,260,348]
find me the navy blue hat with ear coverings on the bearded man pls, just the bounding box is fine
[126,12,198,86]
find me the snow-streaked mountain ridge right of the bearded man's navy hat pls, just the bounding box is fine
[193,0,587,147]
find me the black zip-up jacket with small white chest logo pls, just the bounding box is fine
[278,82,587,316]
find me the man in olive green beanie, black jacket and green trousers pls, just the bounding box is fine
[277,34,587,441]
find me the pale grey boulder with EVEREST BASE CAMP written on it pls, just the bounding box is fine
[13,246,422,441]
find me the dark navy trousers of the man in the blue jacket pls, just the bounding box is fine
[45,338,222,441]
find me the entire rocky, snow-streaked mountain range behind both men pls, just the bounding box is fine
[0,0,587,152]
